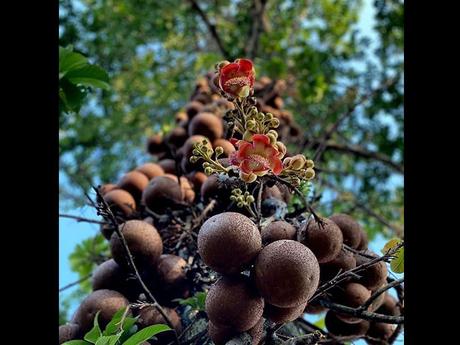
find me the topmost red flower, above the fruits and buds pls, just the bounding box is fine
[219,59,256,97]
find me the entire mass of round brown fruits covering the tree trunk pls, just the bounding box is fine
[59,70,399,345]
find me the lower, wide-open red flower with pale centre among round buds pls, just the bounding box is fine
[230,134,283,181]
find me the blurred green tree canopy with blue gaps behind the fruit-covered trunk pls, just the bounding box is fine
[59,0,404,242]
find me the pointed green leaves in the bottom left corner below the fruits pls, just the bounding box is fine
[63,308,170,345]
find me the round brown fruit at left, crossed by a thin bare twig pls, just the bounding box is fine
[110,220,163,267]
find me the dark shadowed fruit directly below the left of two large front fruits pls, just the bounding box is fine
[206,275,264,332]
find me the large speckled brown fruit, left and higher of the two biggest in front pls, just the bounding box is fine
[198,212,262,274]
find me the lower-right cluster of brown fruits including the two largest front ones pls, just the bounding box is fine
[198,212,399,345]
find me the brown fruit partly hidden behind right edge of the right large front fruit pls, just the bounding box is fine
[297,218,343,264]
